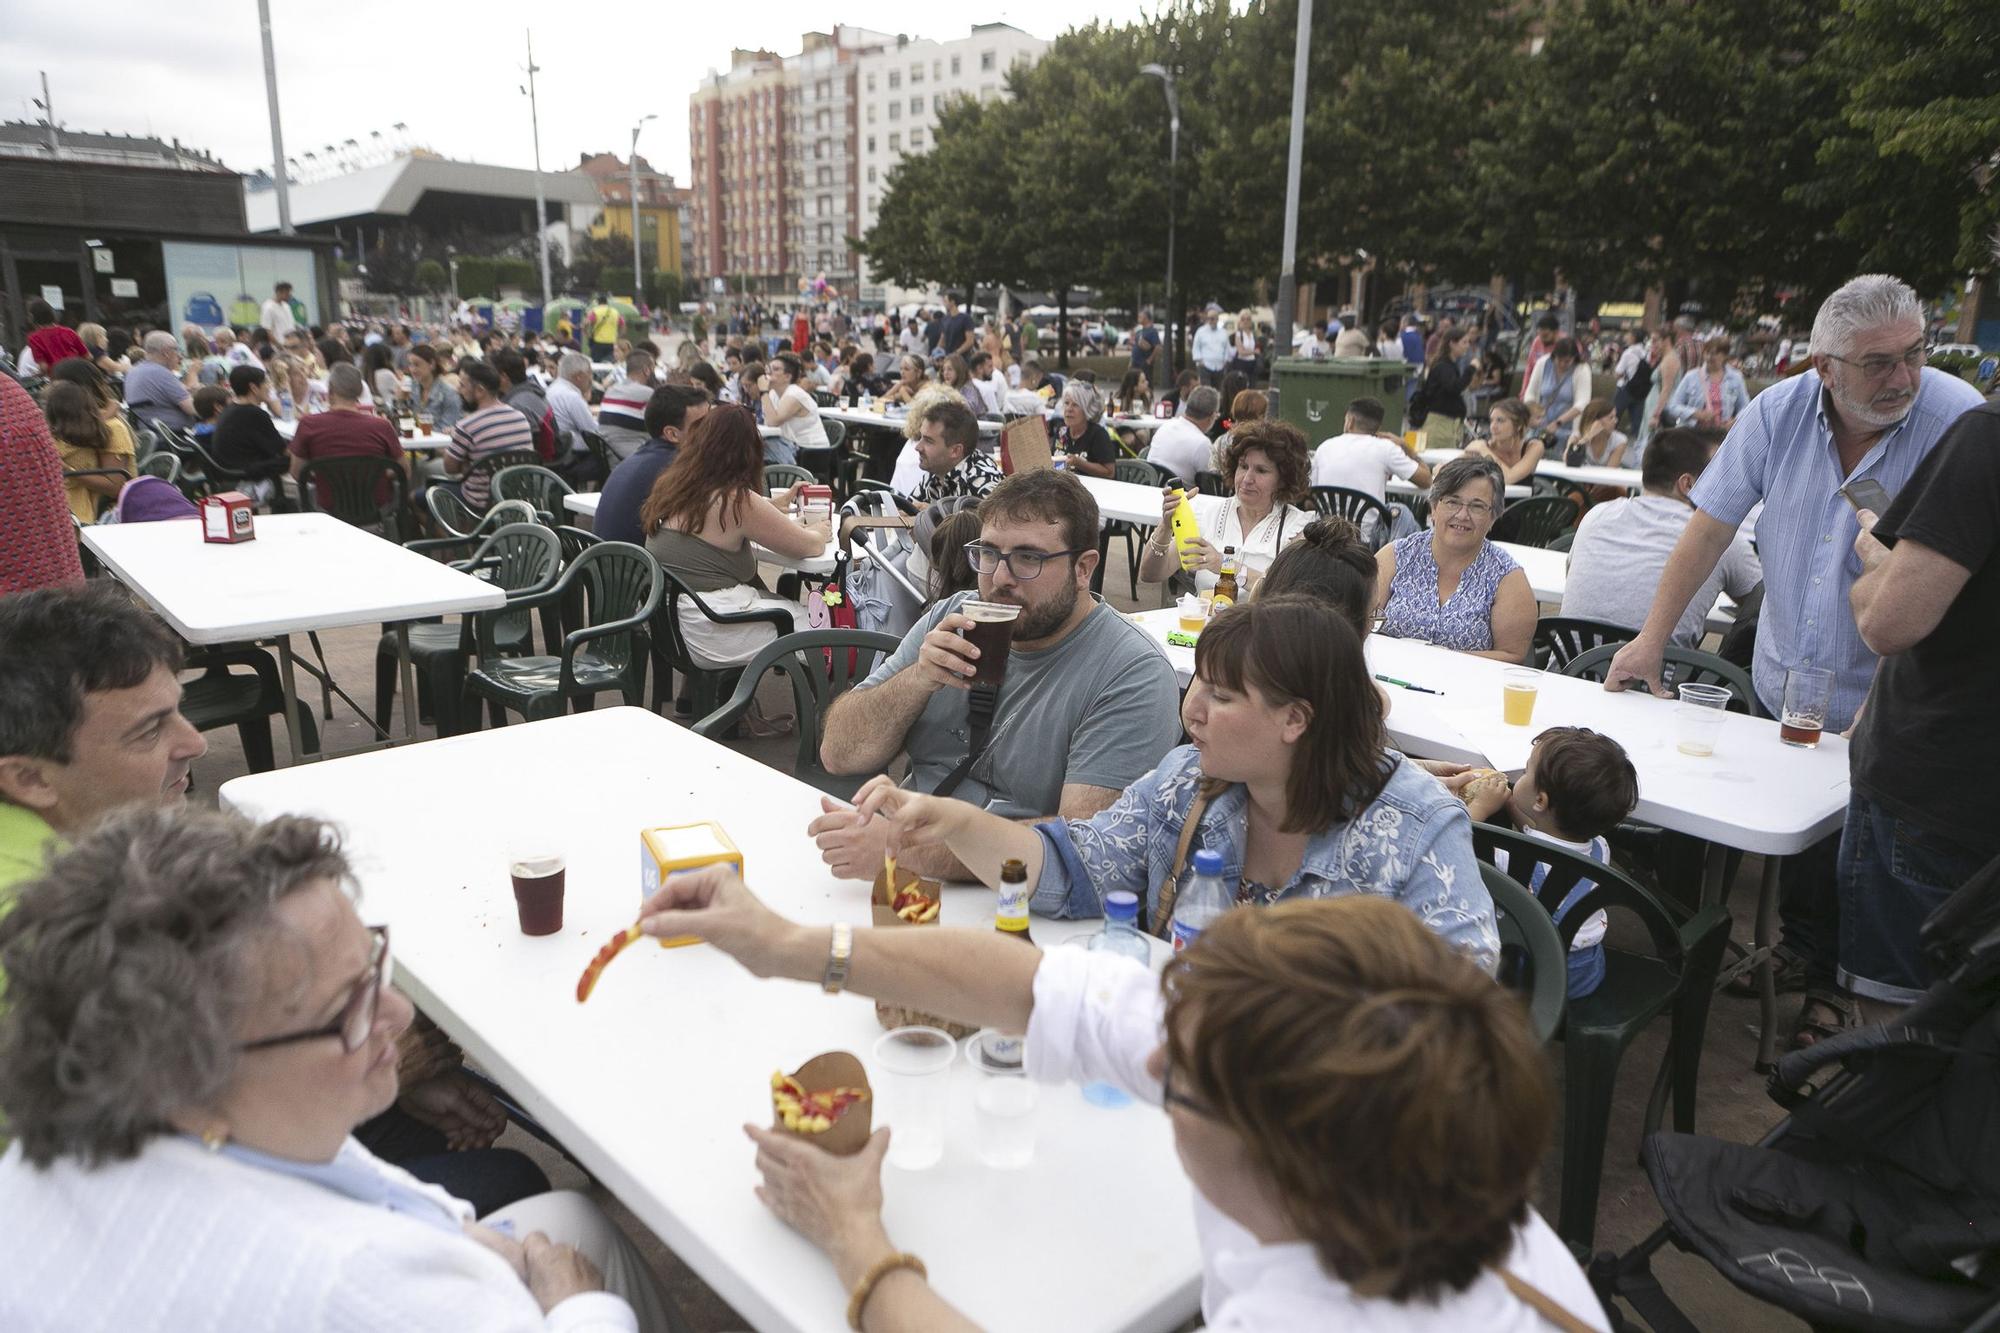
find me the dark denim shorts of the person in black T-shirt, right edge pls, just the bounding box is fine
[1840,793,1992,1005]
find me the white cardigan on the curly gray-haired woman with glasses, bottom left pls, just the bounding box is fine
[0,1137,638,1333]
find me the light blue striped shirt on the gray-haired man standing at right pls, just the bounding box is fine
[1688,366,1980,731]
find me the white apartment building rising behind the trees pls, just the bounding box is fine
[856,24,1048,304]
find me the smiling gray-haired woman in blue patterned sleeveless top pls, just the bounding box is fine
[1376,454,1536,662]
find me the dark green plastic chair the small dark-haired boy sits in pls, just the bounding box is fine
[1472,825,1730,1249]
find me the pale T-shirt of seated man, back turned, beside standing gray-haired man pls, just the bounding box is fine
[1562,494,1764,648]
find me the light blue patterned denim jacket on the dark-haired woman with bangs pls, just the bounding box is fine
[1034,745,1500,971]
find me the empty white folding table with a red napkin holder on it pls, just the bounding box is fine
[82,514,506,763]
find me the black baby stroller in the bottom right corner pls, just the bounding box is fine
[1590,844,2000,1333]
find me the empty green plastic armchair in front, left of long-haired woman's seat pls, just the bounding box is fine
[466,542,666,725]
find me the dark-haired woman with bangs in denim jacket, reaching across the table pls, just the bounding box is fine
[858,596,1500,971]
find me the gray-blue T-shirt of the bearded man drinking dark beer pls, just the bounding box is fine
[860,592,1180,819]
